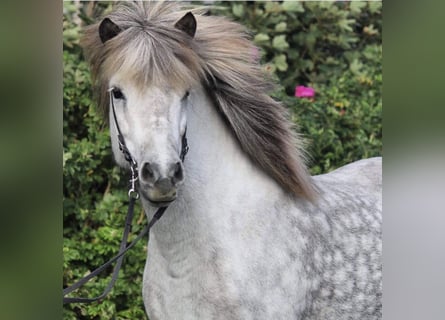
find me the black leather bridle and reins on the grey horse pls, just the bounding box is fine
[63,88,189,304]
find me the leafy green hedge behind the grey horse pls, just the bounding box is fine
[63,1,382,319]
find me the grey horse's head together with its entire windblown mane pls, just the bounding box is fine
[81,1,316,205]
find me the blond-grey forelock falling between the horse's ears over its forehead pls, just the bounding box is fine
[81,1,205,115]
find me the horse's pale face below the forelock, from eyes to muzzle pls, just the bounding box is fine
[110,82,189,204]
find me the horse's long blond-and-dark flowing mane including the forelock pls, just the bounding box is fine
[81,1,315,200]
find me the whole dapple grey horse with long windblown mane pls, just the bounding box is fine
[81,1,382,320]
